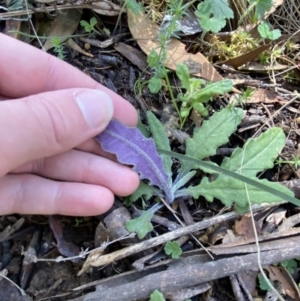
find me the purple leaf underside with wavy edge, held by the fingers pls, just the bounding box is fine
[96,120,174,202]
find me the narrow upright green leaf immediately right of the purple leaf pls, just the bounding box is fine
[147,111,173,179]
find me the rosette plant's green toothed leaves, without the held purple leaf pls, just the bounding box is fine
[126,107,292,238]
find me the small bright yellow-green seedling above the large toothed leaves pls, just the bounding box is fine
[176,64,232,120]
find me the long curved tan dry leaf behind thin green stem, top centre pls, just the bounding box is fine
[127,10,222,81]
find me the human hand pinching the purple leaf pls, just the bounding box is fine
[0,34,139,216]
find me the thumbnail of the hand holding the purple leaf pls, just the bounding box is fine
[74,90,114,128]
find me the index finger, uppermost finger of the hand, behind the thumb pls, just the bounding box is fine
[0,33,137,125]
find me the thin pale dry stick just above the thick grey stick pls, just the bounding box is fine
[78,204,272,276]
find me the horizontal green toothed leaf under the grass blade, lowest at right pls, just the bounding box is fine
[180,175,293,207]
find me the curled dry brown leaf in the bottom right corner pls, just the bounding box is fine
[264,266,300,301]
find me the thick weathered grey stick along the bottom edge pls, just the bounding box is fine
[73,237,300,301]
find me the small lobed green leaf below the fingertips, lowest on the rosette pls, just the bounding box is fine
[125,211,154,239]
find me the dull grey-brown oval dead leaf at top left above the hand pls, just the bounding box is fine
[44,9,82,50]
